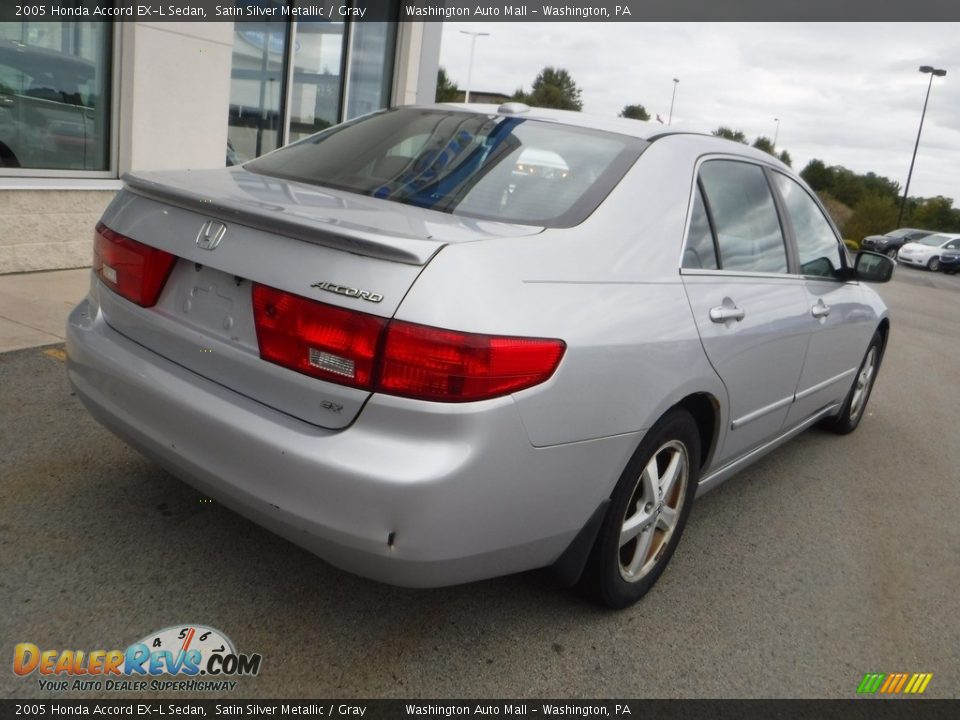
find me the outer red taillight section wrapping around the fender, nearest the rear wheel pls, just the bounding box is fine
[376,321,566,402]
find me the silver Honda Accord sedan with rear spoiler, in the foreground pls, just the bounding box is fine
[67,103,893,607]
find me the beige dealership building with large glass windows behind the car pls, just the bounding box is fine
[0,12,441,274]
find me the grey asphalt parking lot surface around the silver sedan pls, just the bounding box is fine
[0,267,960,698]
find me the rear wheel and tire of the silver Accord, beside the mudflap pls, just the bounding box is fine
[580,408,700,609]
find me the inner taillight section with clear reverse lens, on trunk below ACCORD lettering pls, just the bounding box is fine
[253,285,387,389]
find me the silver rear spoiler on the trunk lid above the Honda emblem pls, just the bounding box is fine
[121,173,445,266]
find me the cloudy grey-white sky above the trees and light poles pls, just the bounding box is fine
[440,22,960,206]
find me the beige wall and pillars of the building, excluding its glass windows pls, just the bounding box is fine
[0,22,441,274]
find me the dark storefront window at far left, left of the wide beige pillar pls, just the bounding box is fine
[0,21,112,171]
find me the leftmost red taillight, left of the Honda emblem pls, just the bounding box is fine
[93,223,177,307]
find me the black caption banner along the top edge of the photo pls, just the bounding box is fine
[0,0,960,22]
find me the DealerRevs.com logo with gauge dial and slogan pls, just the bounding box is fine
[13,624,263,692]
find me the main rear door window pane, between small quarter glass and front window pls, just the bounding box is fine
[700,160,787,273]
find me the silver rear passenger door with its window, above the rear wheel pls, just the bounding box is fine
[681,159,810,464]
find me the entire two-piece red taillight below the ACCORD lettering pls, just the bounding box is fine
[253,284,566,402]
